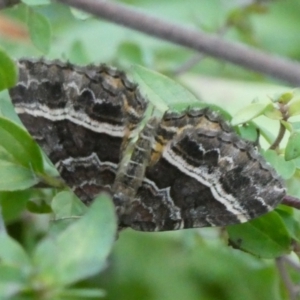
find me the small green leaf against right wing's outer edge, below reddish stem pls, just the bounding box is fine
[263,150,296,179]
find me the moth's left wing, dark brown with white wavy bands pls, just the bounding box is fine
[10,60,146,203]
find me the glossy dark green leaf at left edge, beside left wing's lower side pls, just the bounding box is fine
[0,117,43,172]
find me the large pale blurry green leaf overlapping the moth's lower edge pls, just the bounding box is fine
[34,195,117,285]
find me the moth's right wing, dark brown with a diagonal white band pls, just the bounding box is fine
[118,109,285,231]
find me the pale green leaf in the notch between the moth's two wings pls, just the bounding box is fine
[133,65,200,112]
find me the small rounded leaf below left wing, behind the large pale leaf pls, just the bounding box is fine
[51,191,87,219]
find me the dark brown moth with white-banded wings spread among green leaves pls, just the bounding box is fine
[10,59,286,231]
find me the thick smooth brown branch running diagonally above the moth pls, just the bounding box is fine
[57,0,300,85]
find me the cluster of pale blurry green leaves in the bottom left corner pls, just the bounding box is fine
[0,195,117,300]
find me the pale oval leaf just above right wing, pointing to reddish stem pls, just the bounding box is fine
[231,101,273,126]
